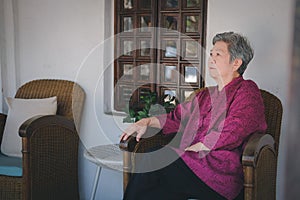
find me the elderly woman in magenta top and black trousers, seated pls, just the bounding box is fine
[121,32,266,200]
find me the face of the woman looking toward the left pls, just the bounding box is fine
[208,41,239,85]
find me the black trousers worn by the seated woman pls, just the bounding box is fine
[124,149,225,200]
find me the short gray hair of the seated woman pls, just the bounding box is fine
[213,32,254,75]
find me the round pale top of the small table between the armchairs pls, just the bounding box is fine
[84,144,123,171]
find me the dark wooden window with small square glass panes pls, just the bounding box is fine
[114,0,207,111]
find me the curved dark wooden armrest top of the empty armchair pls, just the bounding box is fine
[19,115,76,138]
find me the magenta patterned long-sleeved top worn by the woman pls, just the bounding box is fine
[158,77,267,199]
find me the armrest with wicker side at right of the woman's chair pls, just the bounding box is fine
[242,133,277,200]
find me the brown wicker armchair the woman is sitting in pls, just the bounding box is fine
[119,90,282,200]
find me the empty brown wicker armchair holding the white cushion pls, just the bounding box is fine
[0,79,85,200]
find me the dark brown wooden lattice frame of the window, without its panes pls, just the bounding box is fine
[113,0,208,111]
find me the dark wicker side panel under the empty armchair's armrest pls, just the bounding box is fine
[30,125,78,200]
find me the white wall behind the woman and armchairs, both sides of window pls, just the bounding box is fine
[0,0,293,199]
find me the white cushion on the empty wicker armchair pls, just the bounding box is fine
[1,97,57,157]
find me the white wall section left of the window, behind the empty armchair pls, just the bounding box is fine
[1,0,123,199]
